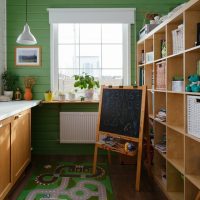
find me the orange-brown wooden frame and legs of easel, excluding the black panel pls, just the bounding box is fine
[93,86,146,191]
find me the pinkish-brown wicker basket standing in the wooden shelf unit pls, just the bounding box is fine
[155,61,166,90]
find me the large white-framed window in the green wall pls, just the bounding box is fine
[50,9,135,91]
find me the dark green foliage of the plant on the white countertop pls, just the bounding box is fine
[1,71,18,91]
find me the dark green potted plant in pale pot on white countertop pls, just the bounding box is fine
[1,71,17,99]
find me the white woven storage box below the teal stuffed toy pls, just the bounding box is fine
[187,96,200,138]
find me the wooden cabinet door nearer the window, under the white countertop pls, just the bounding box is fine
[11,110,31,183]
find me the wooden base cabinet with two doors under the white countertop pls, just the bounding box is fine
[0,110,31,200]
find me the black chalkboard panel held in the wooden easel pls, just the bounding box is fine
[99,88,142,138]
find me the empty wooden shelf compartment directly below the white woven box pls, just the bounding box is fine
[185,137,200,189]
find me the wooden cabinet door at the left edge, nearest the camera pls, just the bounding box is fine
[0,119,12,199]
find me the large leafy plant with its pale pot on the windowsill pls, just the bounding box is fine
[74,72,99,99]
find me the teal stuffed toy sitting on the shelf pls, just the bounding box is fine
[185,74,200,92]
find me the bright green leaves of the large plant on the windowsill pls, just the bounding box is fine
[74,72,99,89]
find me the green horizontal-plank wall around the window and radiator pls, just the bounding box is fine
[7,0,186,154]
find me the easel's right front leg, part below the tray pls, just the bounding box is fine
[135,144,142,192]
